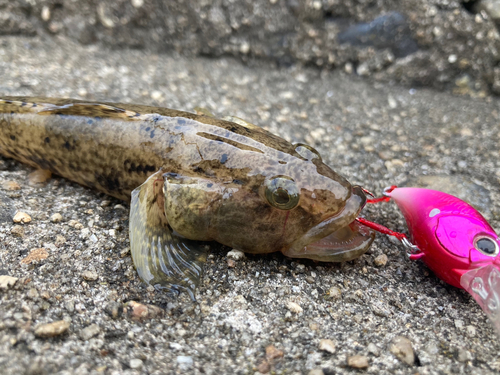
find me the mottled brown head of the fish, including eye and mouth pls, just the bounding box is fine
[165,144,374,261]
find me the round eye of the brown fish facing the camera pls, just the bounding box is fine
[265,176,300,210]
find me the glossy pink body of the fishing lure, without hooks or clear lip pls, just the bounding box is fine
[391,188,500,287]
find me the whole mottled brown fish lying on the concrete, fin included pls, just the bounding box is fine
[0,97,374,297]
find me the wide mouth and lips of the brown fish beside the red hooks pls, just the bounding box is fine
[283,186,375,262]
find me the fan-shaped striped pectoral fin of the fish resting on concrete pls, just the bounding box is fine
[130,170,208,299]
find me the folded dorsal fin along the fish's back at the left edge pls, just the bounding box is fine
[0,98,147,121]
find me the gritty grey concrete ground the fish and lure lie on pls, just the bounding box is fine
[0,37,500,374]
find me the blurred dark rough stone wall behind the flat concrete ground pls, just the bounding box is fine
[0,0,500,96]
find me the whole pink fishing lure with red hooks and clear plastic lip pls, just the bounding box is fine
[360,187,500,334]
